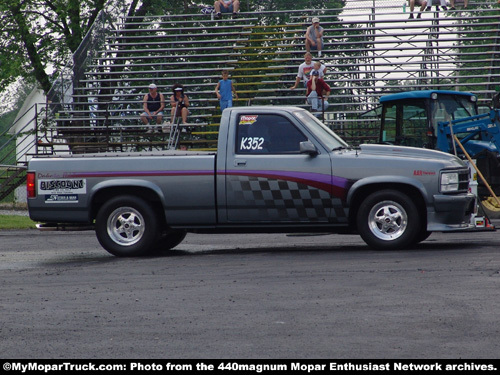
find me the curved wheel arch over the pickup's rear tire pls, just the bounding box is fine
[90,186,165,223]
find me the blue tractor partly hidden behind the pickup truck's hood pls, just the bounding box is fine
[370,90,500,220]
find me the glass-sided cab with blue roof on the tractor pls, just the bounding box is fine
[378,90,481,151]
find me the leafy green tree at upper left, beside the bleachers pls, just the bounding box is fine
[0,0,170,92]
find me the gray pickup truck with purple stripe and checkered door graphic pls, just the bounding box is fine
[27,107,476,256]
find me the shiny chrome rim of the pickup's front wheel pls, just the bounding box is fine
[368,201,408,241]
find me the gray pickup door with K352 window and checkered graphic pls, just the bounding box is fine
[225,113,332,223]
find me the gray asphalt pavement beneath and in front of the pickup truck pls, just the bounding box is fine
[0,230,500,359]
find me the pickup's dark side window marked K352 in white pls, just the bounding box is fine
[236,114,307,154]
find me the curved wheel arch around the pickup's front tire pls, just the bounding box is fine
[349,183,427,228]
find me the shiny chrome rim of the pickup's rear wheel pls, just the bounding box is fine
[106,207,145,246]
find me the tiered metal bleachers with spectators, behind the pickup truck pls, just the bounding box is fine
[35,1,500,153]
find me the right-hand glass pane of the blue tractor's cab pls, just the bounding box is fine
[431,94,477,131]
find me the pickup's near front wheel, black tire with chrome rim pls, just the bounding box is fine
[357,189,422,250]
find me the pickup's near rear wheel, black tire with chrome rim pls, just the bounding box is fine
[95,195,159,257]
